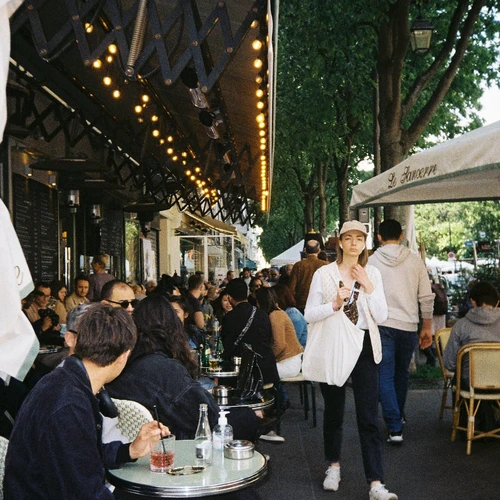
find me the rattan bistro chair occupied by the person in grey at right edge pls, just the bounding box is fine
[451,342,500,455]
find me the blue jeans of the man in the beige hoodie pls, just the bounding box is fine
[379,326,418,432]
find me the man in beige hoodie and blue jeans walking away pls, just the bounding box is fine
[368,219,434,444]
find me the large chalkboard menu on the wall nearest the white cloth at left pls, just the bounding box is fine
[13,174,59,282]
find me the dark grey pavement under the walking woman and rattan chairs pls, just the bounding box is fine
[255,384,500,500]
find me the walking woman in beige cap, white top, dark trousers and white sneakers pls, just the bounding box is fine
[304,221,398,500]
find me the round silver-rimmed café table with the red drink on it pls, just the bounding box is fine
[106,440,267,498]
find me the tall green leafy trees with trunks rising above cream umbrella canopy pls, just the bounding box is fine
[261,0,500,262]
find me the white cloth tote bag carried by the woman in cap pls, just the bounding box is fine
[302,311,365,387]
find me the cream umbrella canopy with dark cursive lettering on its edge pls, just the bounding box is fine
[350,121,500,209]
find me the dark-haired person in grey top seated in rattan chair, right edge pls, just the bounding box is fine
[443,281,500,430]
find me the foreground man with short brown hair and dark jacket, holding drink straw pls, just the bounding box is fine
[4,304,169,500]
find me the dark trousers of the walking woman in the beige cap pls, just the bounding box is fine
[320,332,384,483]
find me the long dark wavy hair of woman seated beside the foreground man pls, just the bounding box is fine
[133,294,197,378]
